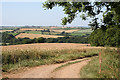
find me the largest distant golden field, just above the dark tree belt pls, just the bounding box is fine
[16,33,64,39]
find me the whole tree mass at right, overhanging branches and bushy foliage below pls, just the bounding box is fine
[43,0,120,46]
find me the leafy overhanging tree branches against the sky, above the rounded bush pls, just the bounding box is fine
[43,0,120,30]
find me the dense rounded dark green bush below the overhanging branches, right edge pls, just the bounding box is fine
[89,26,120,47]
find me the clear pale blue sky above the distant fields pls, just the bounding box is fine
[2,2,90,27]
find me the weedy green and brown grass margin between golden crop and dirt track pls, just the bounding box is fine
[2,49,99,72]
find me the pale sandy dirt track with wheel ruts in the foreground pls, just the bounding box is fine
[3,59,90,78]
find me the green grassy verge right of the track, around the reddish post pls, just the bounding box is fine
[80,49,120,78]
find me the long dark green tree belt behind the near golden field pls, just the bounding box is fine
[0,32,88,45]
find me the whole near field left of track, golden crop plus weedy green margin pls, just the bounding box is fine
[2,43,101,72]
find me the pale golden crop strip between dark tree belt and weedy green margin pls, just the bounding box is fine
[2,43,101,51]
